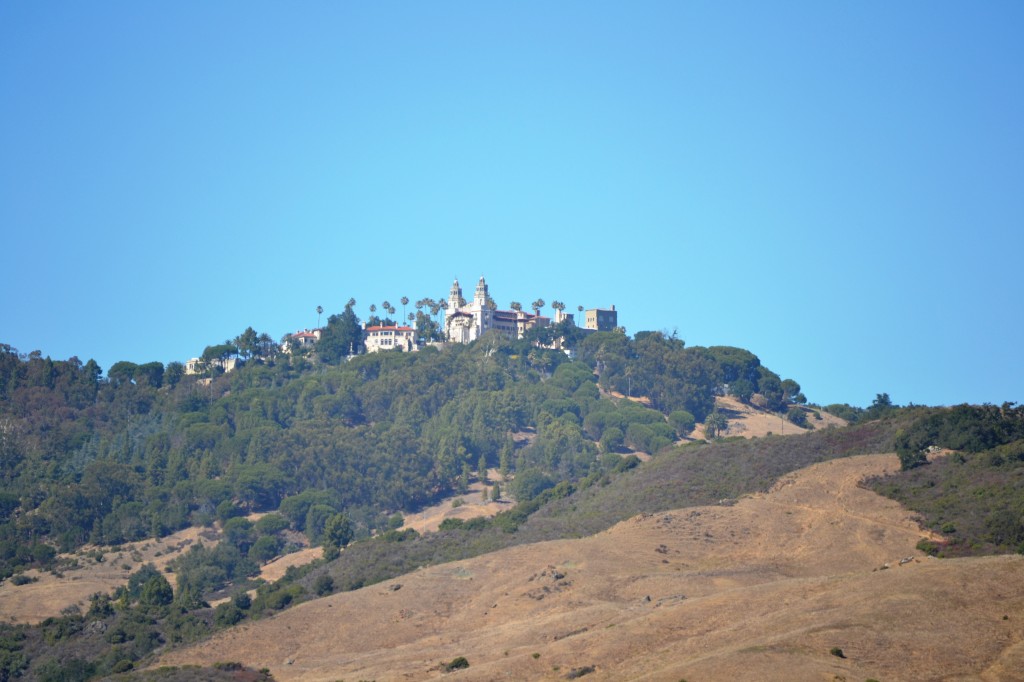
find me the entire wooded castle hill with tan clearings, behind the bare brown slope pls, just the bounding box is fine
[0,332,995,680]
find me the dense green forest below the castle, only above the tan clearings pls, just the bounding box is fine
[0,327,795,578]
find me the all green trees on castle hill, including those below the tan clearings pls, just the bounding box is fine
[0,321,815,679]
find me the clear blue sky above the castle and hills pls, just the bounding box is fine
[0,1,1024,406]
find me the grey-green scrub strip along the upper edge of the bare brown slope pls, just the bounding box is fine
[301,413,900,590]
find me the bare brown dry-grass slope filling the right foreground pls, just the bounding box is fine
[151,455,1024,682]
